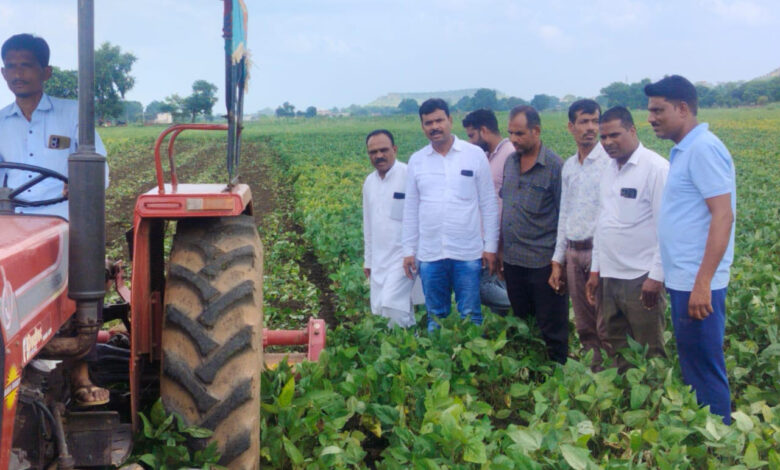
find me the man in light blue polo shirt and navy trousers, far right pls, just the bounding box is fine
[645,75,737,424]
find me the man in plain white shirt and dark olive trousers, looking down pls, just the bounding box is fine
[586,106,669,371]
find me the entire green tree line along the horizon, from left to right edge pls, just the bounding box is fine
[45,42,780,124]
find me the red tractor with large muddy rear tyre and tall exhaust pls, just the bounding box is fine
[0,0,325,470]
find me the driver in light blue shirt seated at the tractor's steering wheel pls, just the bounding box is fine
[0,34,109,406]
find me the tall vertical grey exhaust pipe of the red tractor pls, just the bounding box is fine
[45,0,106,358]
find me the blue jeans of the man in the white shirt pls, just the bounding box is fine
[419,258,482,331]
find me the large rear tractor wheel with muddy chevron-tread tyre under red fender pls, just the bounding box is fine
[160,216,263,469]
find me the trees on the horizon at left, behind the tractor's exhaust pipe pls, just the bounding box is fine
[44,42,218,123]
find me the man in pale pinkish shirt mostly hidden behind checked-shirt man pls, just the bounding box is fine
[463,109,515,315]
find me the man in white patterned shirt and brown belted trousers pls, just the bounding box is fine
[548,99,610,369]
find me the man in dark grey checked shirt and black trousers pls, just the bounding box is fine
[501,106,569,364]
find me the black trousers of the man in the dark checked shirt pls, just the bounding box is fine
[504,263,569,364]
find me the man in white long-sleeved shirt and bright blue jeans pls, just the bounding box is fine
[402,98,498,331]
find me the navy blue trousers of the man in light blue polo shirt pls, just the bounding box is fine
[666,288,731,424]
